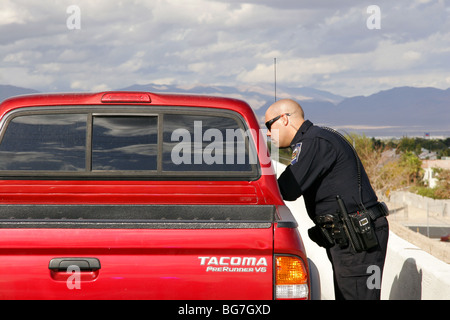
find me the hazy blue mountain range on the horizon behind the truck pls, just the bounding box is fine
[0,84,450,137]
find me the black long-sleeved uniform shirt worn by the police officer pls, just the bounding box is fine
[278,120,378,219]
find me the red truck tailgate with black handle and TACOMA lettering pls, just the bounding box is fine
[0,206,273,299]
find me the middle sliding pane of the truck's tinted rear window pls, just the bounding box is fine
[92,116,158,170]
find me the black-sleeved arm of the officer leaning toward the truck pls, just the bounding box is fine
[278,138,336,201]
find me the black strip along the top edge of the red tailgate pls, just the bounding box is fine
[0,205,276,229]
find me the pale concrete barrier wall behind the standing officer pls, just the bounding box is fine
[275,163,450,300]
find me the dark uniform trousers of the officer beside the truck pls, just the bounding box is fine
[327,217,389,300]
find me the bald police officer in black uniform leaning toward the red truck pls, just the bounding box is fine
[265,99,388,300]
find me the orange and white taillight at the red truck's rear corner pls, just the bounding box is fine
[275,255,309,300]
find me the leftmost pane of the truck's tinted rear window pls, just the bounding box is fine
[0,114,87,171]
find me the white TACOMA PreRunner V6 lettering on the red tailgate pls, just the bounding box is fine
[198,257,267,272]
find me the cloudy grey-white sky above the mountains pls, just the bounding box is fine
[0,0,450,96]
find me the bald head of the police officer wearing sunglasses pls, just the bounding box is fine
[265,99,305,148]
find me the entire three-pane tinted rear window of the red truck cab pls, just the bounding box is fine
[0,106,260,179]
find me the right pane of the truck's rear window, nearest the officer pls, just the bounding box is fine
[163,114,255,172]
